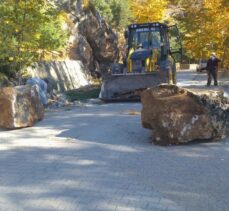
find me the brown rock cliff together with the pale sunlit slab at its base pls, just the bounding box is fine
[28,0,119,92]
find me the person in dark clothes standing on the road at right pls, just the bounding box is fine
[206,53,221,86]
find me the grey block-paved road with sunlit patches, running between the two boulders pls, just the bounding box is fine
[0,72,229,211]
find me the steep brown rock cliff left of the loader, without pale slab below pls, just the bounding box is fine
[57,0,119,74]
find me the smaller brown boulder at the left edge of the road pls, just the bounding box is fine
[0,85,44,129]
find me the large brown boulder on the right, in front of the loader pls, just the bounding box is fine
[141,85,229,145]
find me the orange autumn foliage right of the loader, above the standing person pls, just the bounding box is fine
[180,0,229,65]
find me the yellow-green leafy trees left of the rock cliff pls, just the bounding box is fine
[0,0,68,77]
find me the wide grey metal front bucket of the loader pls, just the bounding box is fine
[99,71,167,102]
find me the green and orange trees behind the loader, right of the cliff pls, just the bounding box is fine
[91,0,229,66]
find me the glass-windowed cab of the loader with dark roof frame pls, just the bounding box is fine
[125,23,182,63]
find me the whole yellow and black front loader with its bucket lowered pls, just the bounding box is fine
[100,23,182,101]
